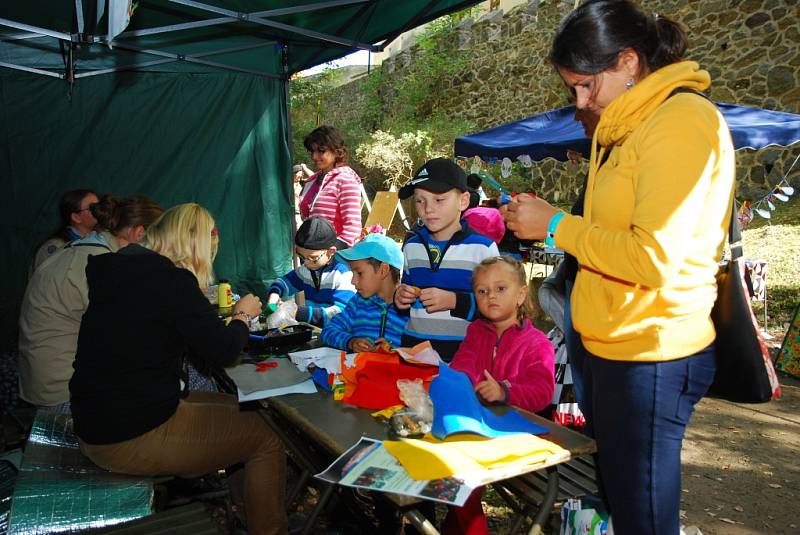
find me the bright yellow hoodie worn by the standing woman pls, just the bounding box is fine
[555,61,735,361]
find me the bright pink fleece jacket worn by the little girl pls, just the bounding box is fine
[450,319,555,412]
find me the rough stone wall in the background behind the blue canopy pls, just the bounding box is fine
[320,0,800,200]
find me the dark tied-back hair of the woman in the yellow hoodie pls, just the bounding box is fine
[549,0,688,74]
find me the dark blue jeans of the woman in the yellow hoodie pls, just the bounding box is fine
[584,345,716,535]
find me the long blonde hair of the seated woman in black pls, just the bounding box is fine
[142,203,219,291]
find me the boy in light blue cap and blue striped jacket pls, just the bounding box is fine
[320,234,408,353]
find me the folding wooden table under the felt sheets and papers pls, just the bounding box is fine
[261,391,595,534]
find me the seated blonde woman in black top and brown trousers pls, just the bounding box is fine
[70,204,286,534]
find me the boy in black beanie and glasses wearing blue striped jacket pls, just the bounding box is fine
[267,217,356,327]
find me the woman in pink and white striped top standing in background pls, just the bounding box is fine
[300,126,361,249]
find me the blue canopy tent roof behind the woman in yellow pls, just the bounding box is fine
[455,102,800,161]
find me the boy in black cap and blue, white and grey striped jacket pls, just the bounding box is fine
[394,158,499,362]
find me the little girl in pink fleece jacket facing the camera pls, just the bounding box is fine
[443,256,555,535]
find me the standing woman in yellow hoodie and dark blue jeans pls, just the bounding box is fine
[506,0,735,535]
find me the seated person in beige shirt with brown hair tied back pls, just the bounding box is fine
[19,195,163,406]
